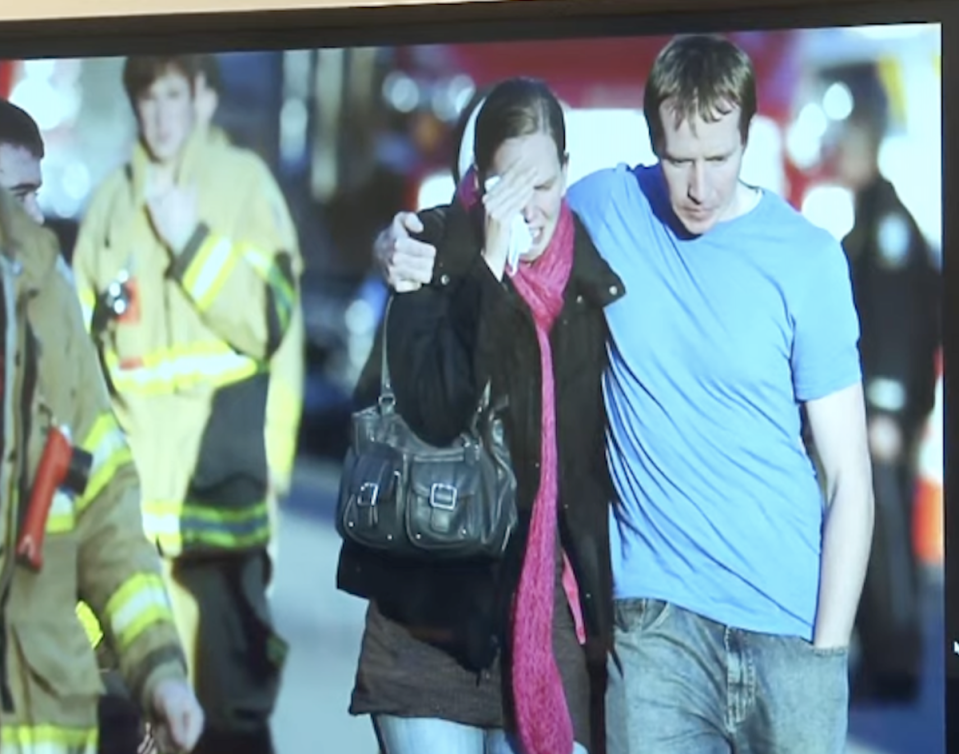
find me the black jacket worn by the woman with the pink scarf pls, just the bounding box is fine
[337,200,624,669]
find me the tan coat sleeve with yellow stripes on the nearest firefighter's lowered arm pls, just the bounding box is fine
[45,262,186,710]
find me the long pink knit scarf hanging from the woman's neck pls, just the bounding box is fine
[458,171,580,754]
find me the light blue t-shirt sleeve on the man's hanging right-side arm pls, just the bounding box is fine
[792,236,862,403]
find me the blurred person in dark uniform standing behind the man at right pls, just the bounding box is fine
[833,97,940,700]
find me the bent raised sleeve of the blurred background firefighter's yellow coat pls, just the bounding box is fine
[170,155,299,361]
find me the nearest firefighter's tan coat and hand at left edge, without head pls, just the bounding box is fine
[0,191,202,754]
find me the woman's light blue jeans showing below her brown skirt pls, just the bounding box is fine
[373,715,586,754]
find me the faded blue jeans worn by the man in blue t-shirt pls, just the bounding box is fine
[606,599,849,754]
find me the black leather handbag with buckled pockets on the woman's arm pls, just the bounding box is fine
[336,298,517,561]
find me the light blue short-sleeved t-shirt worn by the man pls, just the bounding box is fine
[569,165,861,639]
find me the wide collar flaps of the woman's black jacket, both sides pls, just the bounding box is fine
[434,202,625,308]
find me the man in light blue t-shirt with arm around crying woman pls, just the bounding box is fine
[377,36,873,754]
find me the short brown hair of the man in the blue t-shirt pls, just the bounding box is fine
[643,34,756,154]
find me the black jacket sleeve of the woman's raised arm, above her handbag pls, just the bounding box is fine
[386,206,510,445]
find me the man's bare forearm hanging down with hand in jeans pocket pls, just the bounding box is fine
[813,472,874,647]
